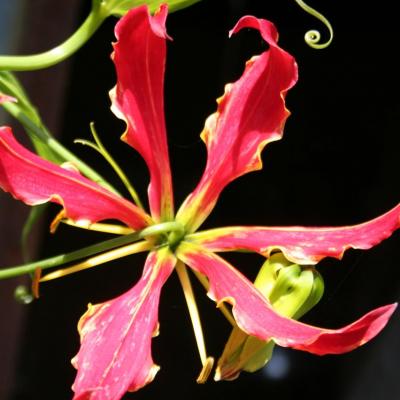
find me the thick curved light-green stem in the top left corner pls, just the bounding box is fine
[0,7,108,71]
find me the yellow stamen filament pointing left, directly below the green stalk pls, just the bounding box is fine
[39,241,152,282]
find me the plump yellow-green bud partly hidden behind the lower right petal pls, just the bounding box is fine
[215,253,324,380]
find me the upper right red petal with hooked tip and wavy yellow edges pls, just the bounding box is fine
[177,16,297,231]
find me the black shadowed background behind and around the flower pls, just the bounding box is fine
[1,0,400,400]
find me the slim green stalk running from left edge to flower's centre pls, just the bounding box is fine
[0,222,183,279]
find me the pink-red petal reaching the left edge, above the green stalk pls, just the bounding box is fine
[0,127,151,229]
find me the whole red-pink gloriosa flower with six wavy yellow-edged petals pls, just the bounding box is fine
[0,6,400,400]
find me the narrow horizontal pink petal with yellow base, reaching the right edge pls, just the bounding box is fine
[187,204,400,264]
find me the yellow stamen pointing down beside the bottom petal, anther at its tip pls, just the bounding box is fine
[176,261,214,383]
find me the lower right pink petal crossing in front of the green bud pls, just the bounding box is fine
[178,243,396,355]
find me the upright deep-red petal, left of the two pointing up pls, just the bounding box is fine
[111,5,173,221]
